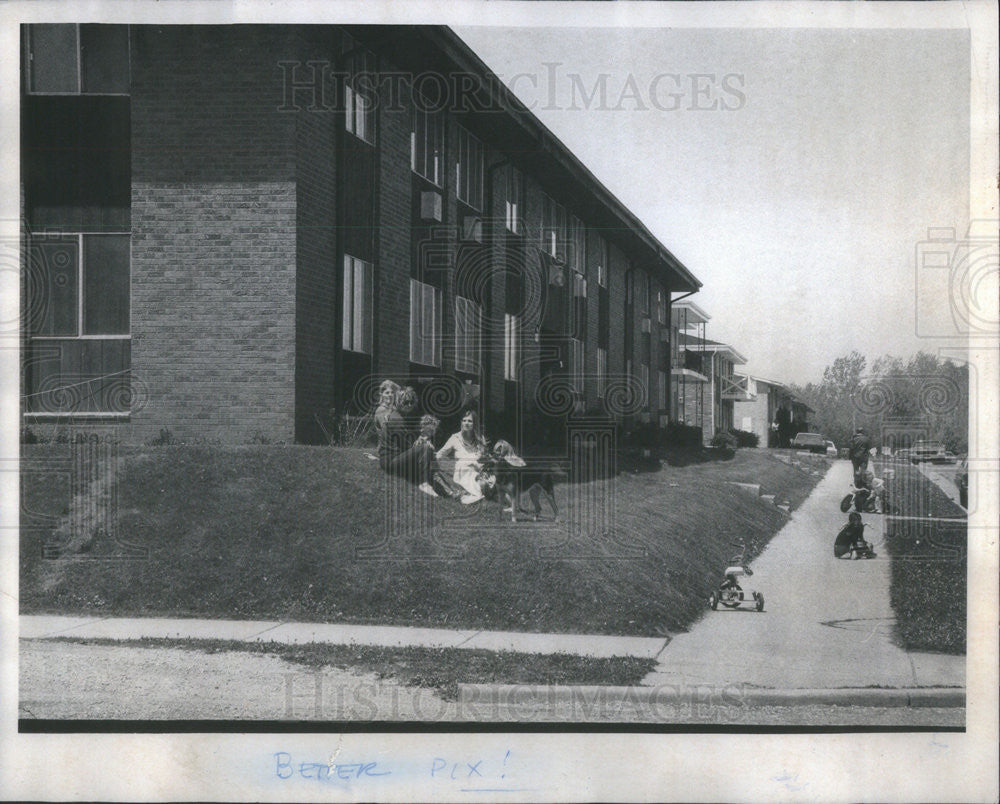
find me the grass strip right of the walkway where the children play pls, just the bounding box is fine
[886,464,968,654]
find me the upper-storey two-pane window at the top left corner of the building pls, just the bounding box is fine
[28,23,131,95]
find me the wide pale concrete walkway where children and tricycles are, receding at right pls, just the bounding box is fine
[643,461,965,689]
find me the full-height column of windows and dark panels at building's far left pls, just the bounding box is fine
[22,24,133,416]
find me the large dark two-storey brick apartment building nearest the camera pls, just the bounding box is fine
[22,25,700,447]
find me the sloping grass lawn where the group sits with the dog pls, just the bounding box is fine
[20,444,829,636]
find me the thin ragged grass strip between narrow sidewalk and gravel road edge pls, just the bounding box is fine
[50,638,656,701]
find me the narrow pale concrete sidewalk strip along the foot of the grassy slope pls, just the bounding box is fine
[19,614,667,659]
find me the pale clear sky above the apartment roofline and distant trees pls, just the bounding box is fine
[455,27,972,383]
